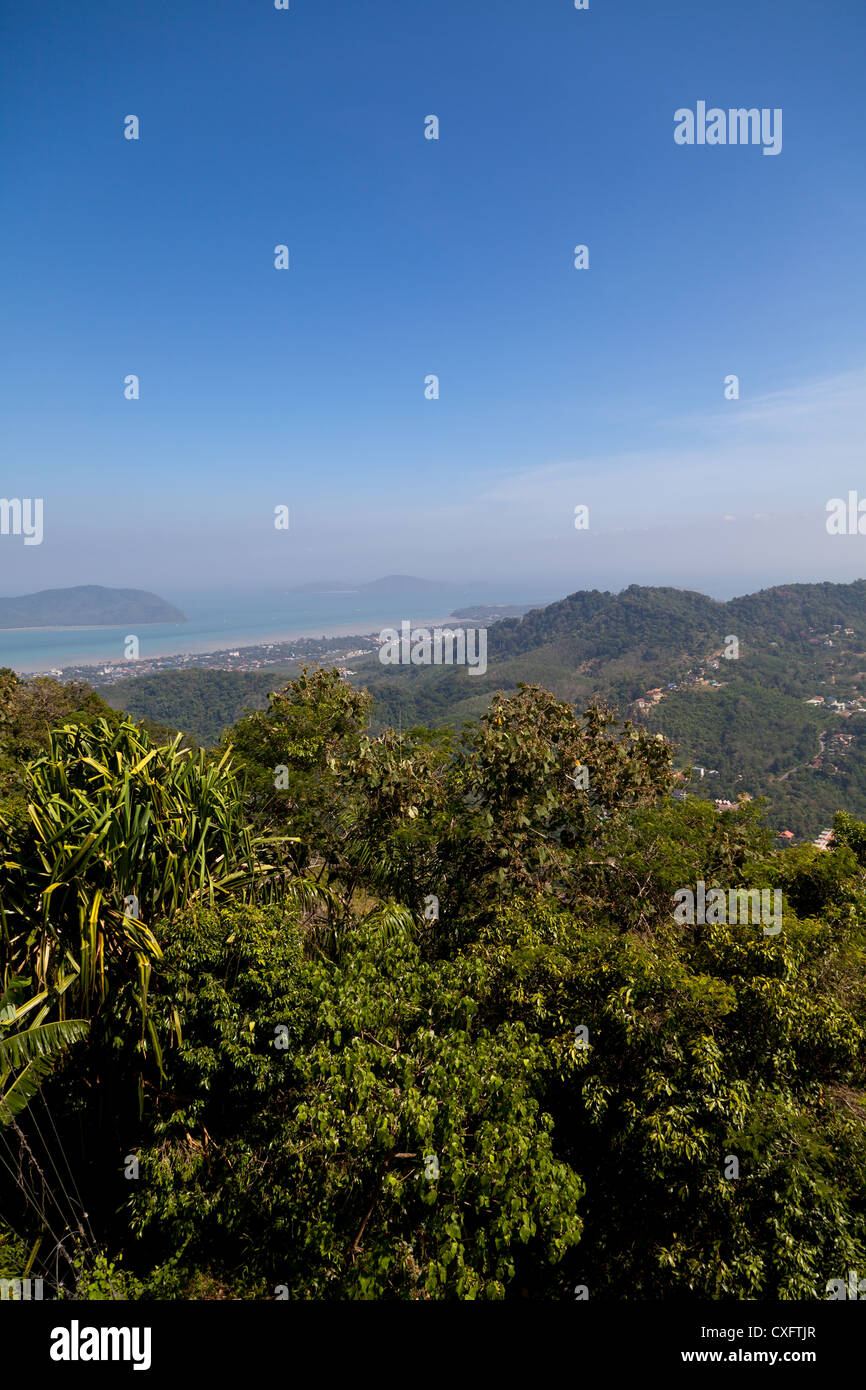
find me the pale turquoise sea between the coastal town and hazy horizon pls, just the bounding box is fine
[0,584,544,676]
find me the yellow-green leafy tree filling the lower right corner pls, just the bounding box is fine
[469,904,866,1298]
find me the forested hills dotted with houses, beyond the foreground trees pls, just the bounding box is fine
[94,580,866,838]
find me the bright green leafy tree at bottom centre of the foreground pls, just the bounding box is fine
[131,909,582,1298]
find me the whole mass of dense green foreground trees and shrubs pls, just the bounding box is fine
[0,671,866,1301]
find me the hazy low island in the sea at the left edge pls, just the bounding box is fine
[0,584,186,628]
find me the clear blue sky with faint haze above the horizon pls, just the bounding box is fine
[0,0,866,599]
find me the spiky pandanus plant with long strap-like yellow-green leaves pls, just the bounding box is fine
[0,719,294,1059]
